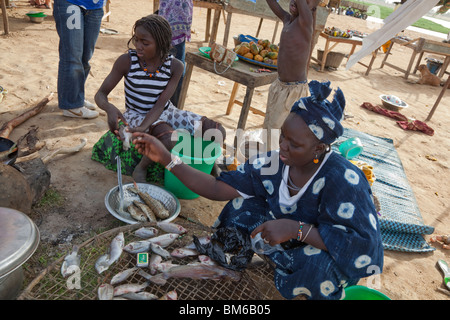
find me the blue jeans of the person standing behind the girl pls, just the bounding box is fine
[53,0,103,109]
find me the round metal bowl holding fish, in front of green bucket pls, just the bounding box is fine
[105,183,181,224]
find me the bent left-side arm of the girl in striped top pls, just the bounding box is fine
[95,54,131,135]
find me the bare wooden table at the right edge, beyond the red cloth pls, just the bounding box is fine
[381,37,450,79]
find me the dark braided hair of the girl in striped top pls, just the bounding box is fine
[128,14,172,60]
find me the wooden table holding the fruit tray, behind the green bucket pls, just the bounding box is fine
[178,52,278,130]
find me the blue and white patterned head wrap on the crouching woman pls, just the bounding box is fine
[291,80,345,144]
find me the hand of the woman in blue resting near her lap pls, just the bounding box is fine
[250,219,298,246]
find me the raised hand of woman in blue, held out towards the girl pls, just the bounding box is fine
[133,132,172,166]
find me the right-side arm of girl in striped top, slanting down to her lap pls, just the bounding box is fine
[134,58,184,132]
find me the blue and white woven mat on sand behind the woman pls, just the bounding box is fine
[333,129,435,252]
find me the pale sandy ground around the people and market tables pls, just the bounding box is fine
[0,0,450,300]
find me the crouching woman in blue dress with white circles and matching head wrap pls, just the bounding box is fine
[130,81,383,299]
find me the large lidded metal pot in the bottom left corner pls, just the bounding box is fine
[0,207,39,300]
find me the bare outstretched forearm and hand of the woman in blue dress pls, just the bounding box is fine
[133,132,240,201]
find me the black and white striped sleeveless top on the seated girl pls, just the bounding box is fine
[124,50,173,114]
